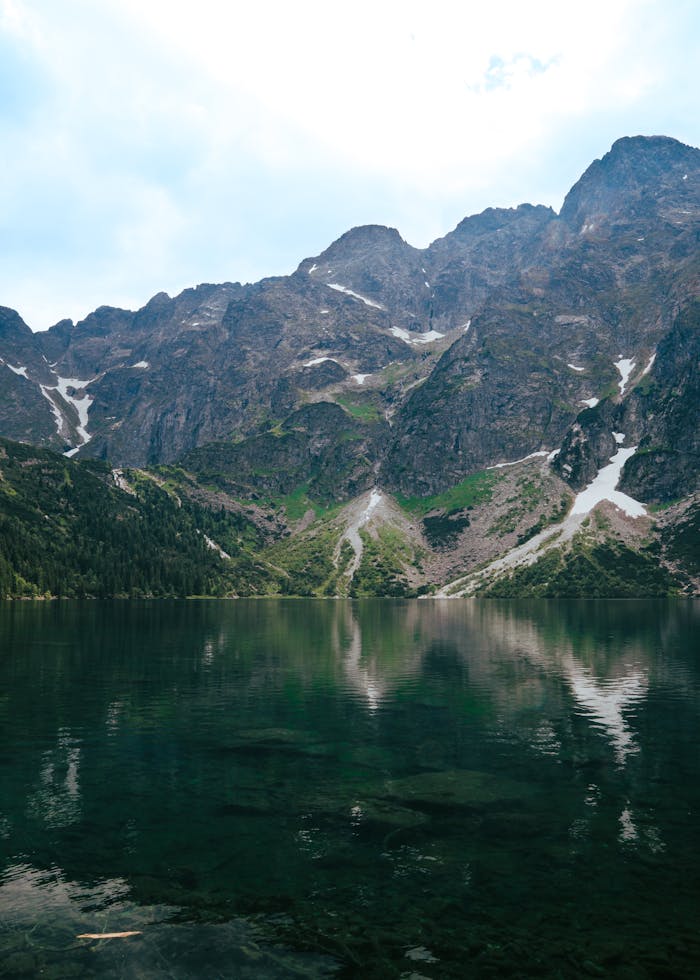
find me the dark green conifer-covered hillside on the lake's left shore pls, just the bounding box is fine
[0,439,274,597]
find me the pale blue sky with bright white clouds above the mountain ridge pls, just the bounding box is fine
[0,0,700,330]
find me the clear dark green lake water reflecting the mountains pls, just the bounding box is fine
[0,600,700,980]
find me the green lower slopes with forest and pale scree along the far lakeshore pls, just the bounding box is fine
[0,434,700,598]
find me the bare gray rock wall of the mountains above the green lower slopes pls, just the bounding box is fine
[0,137,700,500]
